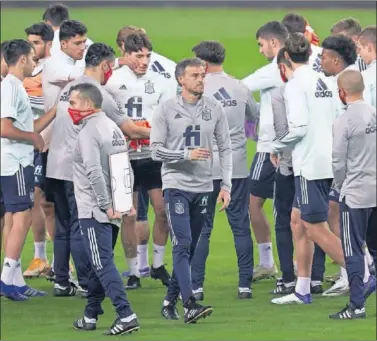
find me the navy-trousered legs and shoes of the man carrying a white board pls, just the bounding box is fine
[74,219,139,335]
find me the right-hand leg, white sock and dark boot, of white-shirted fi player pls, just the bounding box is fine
[143,160,170,286]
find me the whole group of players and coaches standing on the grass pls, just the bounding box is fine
[0,4,377,335]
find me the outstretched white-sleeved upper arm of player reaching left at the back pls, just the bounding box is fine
[242,63,282,92]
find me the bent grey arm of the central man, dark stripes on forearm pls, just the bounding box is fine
[150,104,189,162]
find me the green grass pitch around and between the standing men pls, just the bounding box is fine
[1,8,376,340]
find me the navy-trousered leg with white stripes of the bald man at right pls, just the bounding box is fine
[330,200,371,319]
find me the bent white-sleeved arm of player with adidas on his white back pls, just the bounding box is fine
[271,83,309,154]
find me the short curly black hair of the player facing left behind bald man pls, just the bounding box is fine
[322,35,357,66]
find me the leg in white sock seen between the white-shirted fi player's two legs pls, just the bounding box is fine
[136,187,150,277]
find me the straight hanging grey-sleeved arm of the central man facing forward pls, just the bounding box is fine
[214,106,233,193]
